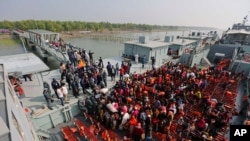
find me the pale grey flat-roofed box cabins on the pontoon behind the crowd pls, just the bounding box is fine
[123,36,197,65]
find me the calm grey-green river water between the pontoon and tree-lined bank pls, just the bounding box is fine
[0,31,222,70]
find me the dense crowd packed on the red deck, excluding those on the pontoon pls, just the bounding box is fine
[96,62,241,140]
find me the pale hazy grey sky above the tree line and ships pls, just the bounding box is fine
[0,0,250,29]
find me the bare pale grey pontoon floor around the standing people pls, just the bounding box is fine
[20,57,151,110]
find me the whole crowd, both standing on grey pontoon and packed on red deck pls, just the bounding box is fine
[41,46,241,141]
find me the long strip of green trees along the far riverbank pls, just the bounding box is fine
[0,20,178,32]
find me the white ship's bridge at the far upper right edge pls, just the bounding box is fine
[221,23,250,45]
